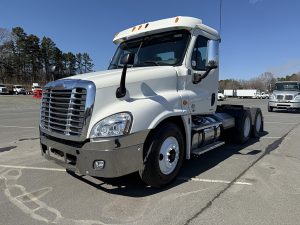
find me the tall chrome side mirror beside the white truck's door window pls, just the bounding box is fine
[206,40,219,69]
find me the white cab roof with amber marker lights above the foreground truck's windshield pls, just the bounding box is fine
[113,16,220,44]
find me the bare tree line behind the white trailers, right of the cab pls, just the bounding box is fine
[219,72,300,92]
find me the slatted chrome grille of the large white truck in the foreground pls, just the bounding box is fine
[41,88,87,136]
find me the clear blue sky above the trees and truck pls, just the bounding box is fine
[0,0,300,79]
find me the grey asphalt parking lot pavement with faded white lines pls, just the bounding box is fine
[0,96,300,225]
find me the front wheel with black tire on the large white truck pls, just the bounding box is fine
[139,123,184,187]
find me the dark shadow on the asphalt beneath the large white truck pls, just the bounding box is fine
[69,132,268,197]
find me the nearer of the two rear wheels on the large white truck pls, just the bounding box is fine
[234,110,252,144]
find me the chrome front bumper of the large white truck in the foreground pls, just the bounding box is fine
[40,130,149,177]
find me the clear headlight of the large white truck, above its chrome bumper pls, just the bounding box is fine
[90,112,132,138]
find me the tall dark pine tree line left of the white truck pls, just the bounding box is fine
[0,27,94,84]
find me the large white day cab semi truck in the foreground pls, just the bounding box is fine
[40,17,263,187]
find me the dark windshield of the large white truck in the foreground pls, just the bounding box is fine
[108,30,190,69]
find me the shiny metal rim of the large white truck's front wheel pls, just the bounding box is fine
[159,137,179,175]
